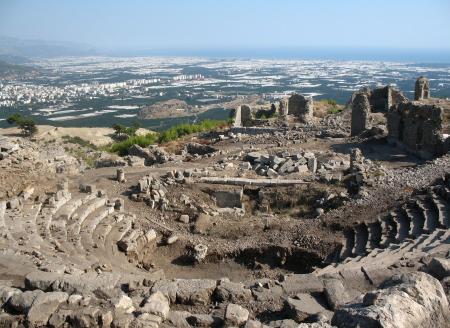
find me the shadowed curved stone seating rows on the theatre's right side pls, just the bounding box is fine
[316,175,450,274]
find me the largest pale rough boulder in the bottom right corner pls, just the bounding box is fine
[332,272,450,328]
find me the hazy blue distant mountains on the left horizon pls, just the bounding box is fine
[0,36,96,60]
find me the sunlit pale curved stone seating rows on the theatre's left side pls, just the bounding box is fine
[0,183,154,272]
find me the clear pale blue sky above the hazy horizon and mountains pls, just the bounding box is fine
[0,0,450,51]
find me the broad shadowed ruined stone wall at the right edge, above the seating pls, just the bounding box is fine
[387,101,450,158]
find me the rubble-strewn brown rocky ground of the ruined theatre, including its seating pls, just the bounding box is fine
[0,111,450,328]
